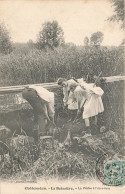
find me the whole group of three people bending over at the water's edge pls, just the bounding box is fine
[22,73,104,138]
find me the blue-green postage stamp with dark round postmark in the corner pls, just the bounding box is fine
[96,154,125,186]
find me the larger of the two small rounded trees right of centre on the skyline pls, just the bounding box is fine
[90,32,104,46]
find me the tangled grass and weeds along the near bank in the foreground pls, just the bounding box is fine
[0,124,121,182]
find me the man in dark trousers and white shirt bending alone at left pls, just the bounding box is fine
[22,86,54,135]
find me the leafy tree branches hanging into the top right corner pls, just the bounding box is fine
[108,0,125,29]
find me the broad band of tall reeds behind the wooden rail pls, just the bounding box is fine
[0,46,124,86]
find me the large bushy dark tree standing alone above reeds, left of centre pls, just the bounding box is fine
[37,21,64,49]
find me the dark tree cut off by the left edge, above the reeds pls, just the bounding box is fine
[0,24,12,54]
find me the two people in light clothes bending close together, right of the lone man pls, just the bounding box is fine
[57,75,104,134]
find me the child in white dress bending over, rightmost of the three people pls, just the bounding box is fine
[69,81,104,132]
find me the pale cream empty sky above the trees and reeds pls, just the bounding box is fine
[0,0,124,46]
